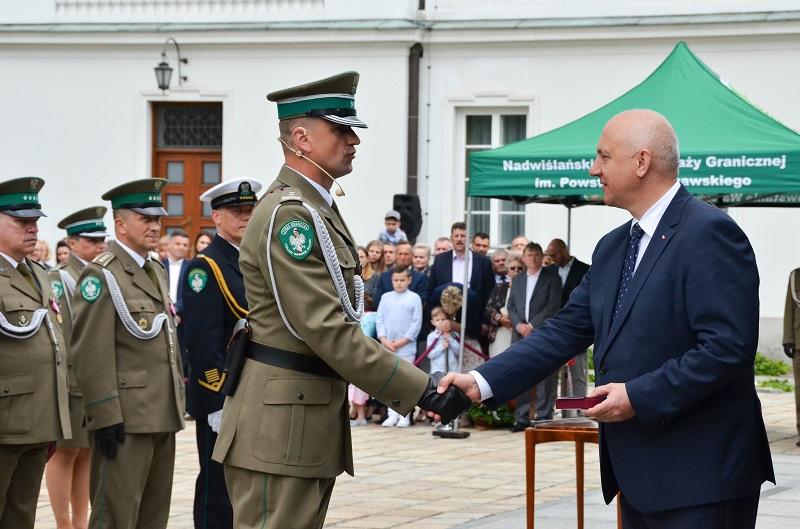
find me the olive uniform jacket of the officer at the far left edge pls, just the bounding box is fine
[0,256,72,444]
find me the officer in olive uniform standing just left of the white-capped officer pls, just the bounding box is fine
[70,178,184,529]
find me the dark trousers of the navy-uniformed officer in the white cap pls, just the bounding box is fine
[194,419,233,529]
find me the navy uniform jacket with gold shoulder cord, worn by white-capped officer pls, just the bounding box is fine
[181,235,247,419]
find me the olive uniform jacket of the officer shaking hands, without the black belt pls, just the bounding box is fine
[209,167,428,478]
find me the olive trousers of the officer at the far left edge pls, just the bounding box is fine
[0,443,47,529]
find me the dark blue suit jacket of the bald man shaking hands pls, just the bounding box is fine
[478,187,775,512]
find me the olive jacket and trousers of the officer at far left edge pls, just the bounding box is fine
[0,256,72,529]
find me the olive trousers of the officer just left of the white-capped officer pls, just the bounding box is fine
[89,433,175,529]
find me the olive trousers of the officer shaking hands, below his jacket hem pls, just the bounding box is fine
[225,465,336,529]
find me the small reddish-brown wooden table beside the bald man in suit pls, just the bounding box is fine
[525,418,622,529]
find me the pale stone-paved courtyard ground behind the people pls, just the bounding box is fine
[36,386,800,529]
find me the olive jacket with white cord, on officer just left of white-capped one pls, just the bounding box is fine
[70,242,184,433]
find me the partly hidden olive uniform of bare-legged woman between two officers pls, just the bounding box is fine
[48,254,89,448]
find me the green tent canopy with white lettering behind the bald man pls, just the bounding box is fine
[468,42,800,206]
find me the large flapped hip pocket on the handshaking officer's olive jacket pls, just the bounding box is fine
[253,377,334,466]
